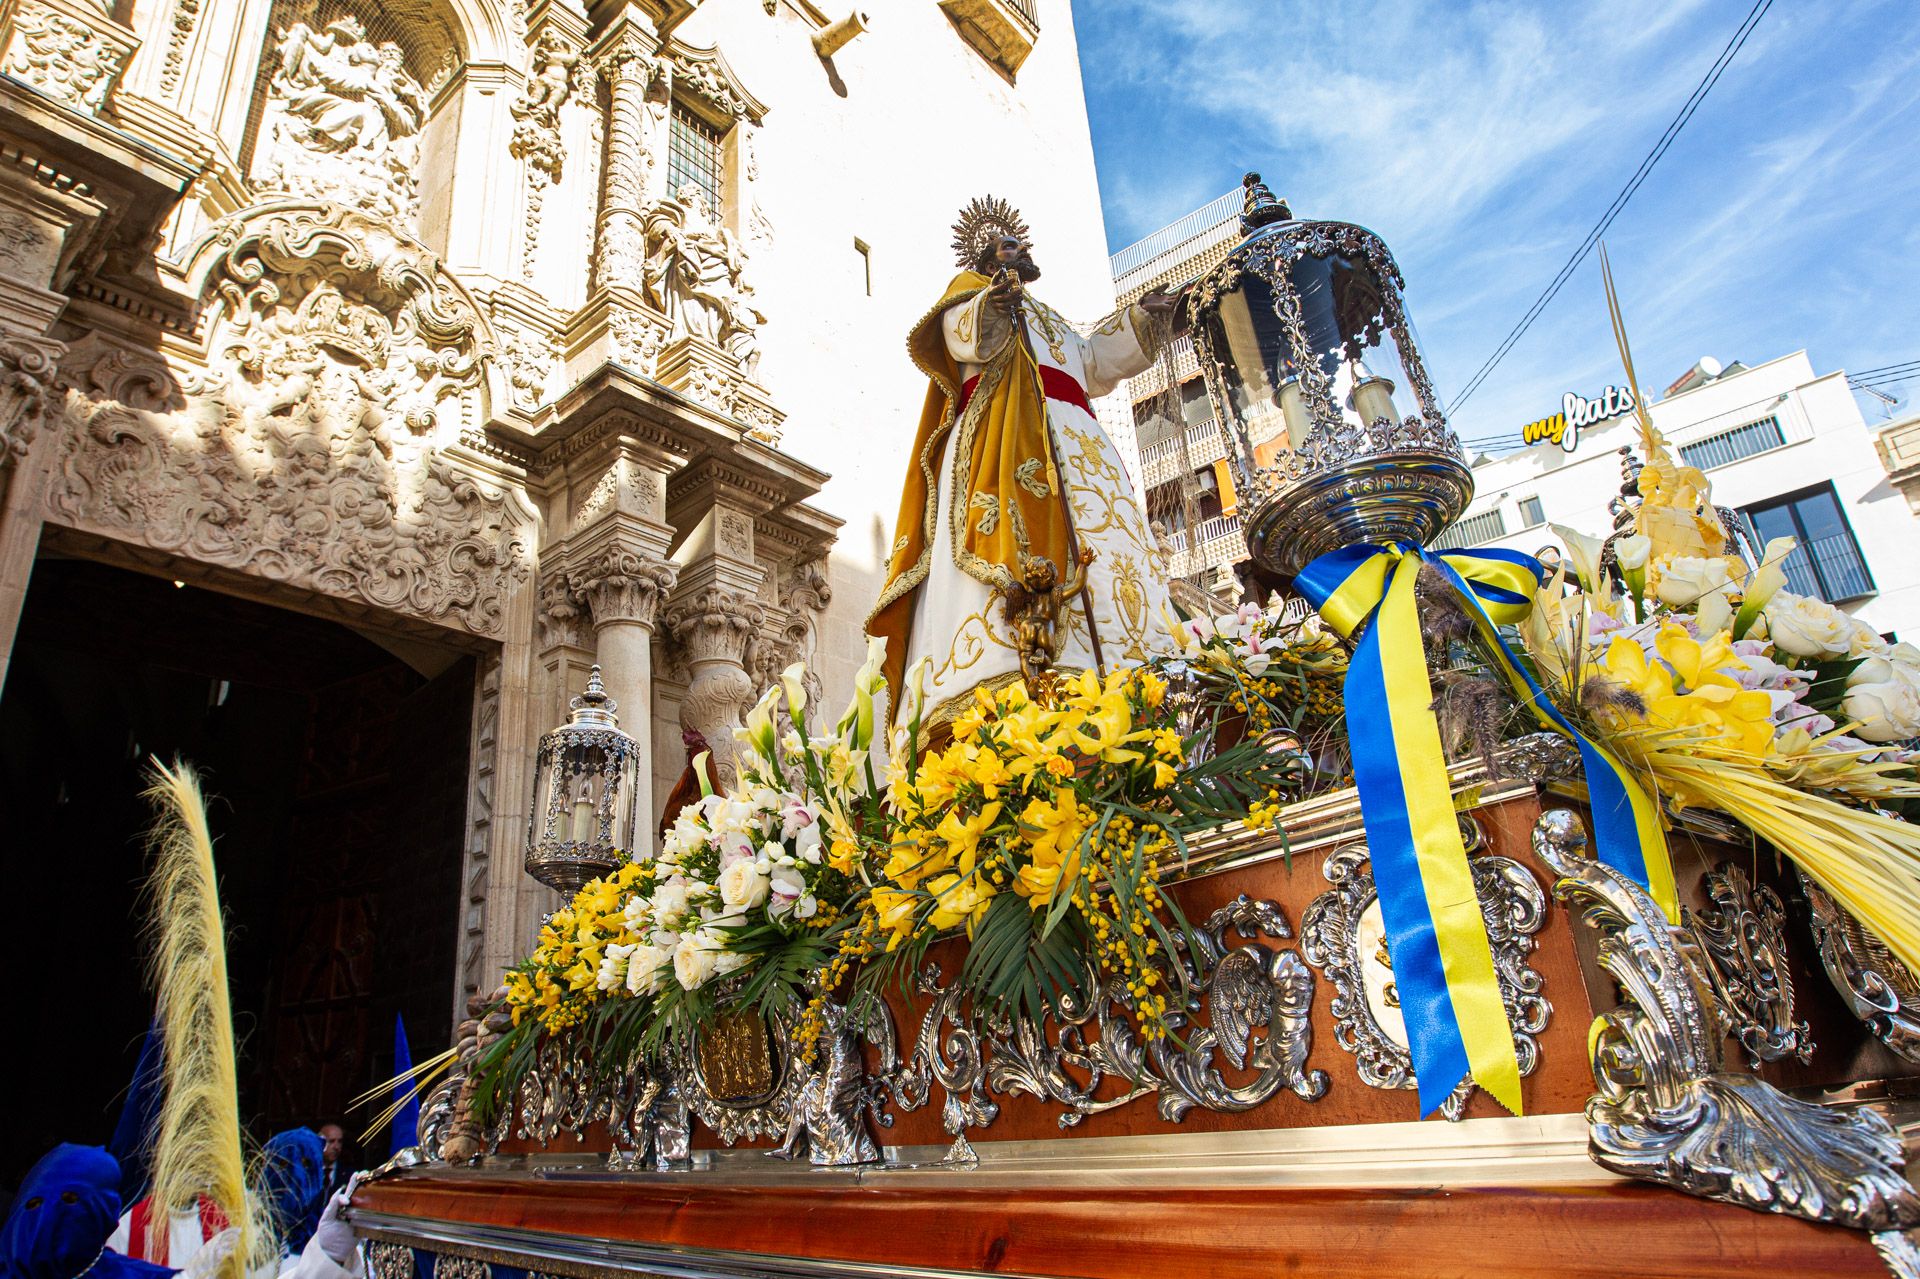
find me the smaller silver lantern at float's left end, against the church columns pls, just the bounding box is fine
[526,666,643,897]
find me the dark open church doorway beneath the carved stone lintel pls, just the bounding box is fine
[0,559,474,1185]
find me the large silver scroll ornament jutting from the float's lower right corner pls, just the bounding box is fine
[1534,810,1920,1233]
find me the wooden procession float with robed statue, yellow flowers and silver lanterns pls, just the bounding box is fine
[353,179,1920,1279]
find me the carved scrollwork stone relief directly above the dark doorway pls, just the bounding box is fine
[48,205,532,638]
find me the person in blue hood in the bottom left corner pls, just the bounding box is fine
[0,1145,179,1279]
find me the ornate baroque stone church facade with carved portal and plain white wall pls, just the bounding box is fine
[0,0,1112,1106]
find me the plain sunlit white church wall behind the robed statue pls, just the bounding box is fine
[676,0,1114,697]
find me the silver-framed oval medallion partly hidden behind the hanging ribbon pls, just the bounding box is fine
[1300,825,1553,1120]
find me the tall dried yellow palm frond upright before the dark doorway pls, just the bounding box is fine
[144,759,257,1279]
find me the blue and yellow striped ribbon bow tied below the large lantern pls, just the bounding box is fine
[1294,543,1678,1114]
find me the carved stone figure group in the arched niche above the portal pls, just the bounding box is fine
[253,13,426,230]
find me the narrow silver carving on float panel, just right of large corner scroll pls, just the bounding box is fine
[1692,862,1812,1070]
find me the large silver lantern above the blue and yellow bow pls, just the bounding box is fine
[1187,173,1473,580]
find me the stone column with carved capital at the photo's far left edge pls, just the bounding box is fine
[0,336,67,688]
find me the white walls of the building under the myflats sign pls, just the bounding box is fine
[1467,351,1920,640]
